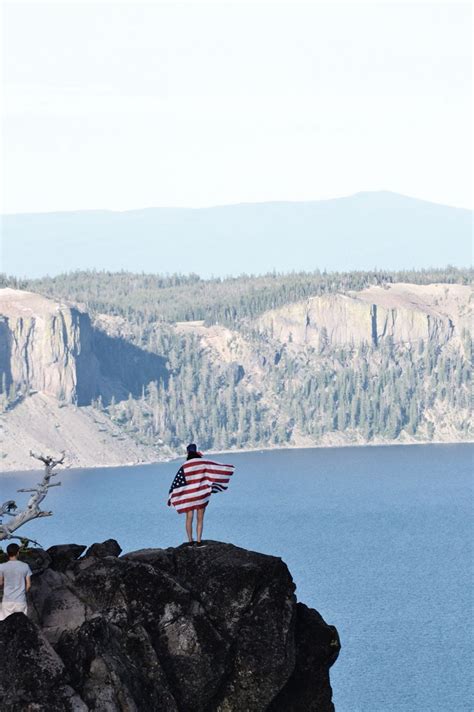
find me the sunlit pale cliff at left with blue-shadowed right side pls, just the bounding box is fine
[0,288,167,406]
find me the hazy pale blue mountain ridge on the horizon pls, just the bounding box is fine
[0,192,472,277]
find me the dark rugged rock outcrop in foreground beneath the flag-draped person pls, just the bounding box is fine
[0,540,340,712]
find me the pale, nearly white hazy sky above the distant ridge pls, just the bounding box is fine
[1,0,472,212]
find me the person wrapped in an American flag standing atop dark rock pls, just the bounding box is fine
[168,443,234,547]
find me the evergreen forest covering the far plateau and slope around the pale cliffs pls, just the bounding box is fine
[0,267,472,450]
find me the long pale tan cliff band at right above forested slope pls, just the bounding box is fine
[256,283,472,349]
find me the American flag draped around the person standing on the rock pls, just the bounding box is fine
[168,458,234,512]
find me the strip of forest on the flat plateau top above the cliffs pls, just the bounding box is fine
[0,267,473,327]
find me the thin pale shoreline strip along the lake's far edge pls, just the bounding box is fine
[0,440,474,479]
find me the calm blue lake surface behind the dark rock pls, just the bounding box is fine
[0,445,474,712]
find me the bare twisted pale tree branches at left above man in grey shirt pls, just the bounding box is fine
[0,451,65,541]
